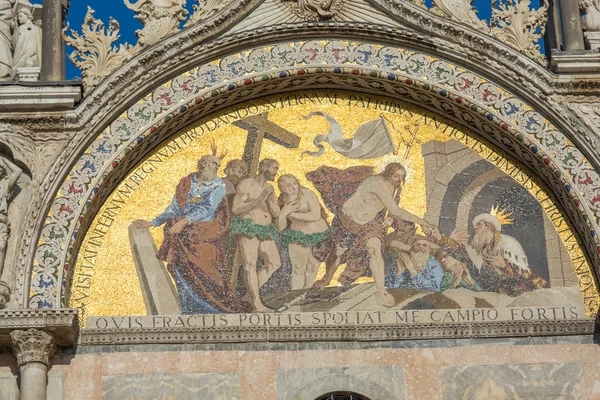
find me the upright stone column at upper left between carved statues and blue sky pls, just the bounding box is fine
[42,0,70,81]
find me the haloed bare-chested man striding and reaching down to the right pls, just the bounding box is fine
[313,163,430,307]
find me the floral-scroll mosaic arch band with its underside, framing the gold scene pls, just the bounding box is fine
[29,40,600,308]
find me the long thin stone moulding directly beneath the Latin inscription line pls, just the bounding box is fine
[79,319,595,345]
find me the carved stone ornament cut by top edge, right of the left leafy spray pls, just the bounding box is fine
[124,0,188,48]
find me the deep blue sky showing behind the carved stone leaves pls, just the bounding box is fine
[59,0,539,79]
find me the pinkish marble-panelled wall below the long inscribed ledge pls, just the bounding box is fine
[0,336,600,400]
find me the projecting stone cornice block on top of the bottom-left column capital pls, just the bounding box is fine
[0,309,79,346]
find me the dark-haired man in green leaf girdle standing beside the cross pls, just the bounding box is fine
[230,158,281,312]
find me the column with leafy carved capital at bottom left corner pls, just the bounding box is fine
[10,329,56,400]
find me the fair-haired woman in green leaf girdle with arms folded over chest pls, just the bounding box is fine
[277,175,329,290]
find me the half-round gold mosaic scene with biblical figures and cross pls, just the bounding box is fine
[71,92,582,316]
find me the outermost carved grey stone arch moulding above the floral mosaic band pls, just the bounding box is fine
[7,16,600,306]
